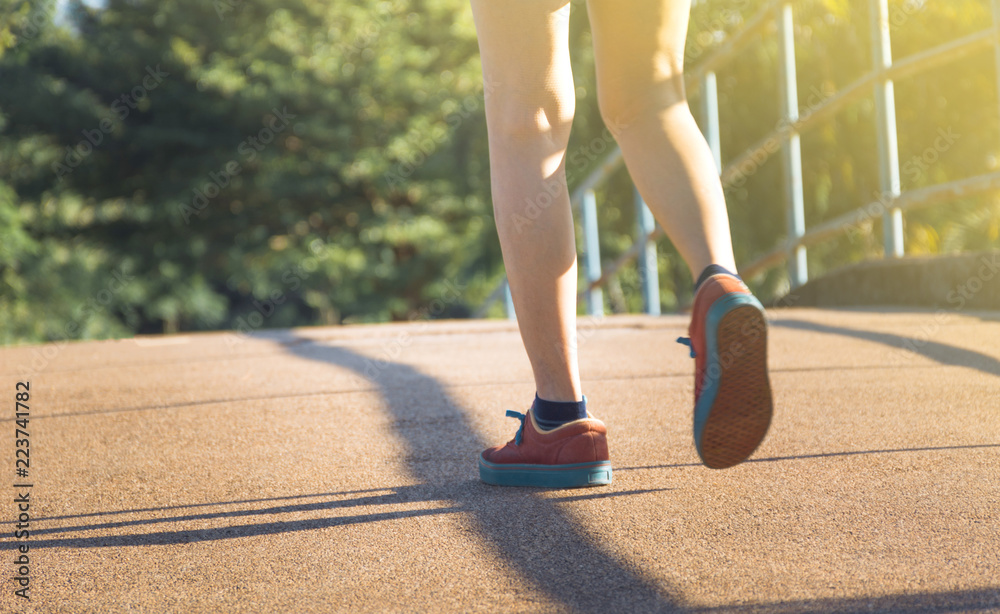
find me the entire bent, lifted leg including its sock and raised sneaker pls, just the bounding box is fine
[587,0,772,468]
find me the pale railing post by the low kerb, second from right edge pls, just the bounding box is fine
[871,0,903,258]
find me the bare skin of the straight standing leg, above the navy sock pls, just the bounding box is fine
[472,0,582,401]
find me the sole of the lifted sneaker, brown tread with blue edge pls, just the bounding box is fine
[694,293,772,468]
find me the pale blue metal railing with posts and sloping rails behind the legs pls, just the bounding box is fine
[477,0,1000,318]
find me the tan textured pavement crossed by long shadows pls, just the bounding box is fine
[0,309,1000,614]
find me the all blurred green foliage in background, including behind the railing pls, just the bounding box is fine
[0,0,1000,343]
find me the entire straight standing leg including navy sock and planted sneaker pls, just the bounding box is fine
[472,0,611,487]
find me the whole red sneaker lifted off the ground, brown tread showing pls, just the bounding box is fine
[677,273,773,469]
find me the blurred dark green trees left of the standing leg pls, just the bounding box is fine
[0,0,502,343]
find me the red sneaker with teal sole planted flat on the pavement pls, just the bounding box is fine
[479,409,611,488]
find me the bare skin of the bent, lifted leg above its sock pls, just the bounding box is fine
[587,0,736,278]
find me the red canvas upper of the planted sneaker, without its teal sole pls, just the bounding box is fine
[483,410,609,465]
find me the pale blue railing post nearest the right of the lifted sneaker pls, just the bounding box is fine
[777,2,809,288]
